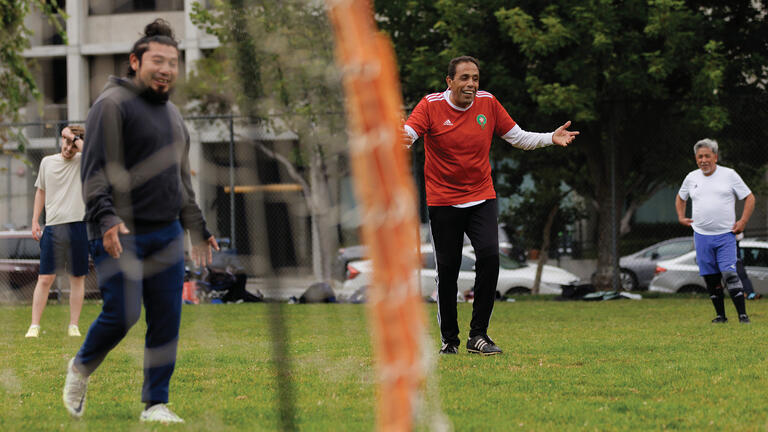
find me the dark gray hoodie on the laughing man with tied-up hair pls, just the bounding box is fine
[80,76,210,243]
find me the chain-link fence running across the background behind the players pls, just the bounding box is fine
[0,99,768,302]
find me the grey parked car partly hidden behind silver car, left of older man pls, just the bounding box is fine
[619,237,694,291]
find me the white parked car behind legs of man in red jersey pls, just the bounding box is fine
[336,244,579,300]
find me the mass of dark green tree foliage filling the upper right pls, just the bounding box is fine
[375,0,768,286]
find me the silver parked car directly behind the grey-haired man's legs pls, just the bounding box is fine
[649,240,768,295]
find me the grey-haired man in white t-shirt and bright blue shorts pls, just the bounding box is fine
[675,139,755,324]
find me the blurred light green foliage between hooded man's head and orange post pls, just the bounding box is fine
[184,0,345,154]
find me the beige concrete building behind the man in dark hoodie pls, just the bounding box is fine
[0,0,330,276]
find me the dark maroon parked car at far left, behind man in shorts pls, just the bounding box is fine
[0,231,101,301]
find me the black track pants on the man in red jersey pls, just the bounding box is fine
[429,199,499,346]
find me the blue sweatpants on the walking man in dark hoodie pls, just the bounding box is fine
[75,221,184,403]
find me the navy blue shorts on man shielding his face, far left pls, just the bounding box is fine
[40,222,88,276]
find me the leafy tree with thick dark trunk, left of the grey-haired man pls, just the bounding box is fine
[496,0,765,287]
